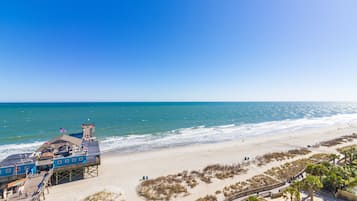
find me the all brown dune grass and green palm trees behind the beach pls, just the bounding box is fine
[137,138,357,201]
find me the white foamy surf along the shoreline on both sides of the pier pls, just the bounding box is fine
[0,114,357,159]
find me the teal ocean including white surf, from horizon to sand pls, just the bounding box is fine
[0,102,357,159]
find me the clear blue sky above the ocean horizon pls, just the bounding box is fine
[0,0,357,102]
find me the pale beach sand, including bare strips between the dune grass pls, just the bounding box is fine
[46,123,357,201]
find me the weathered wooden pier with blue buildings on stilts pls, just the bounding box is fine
[0,124,100,201]
